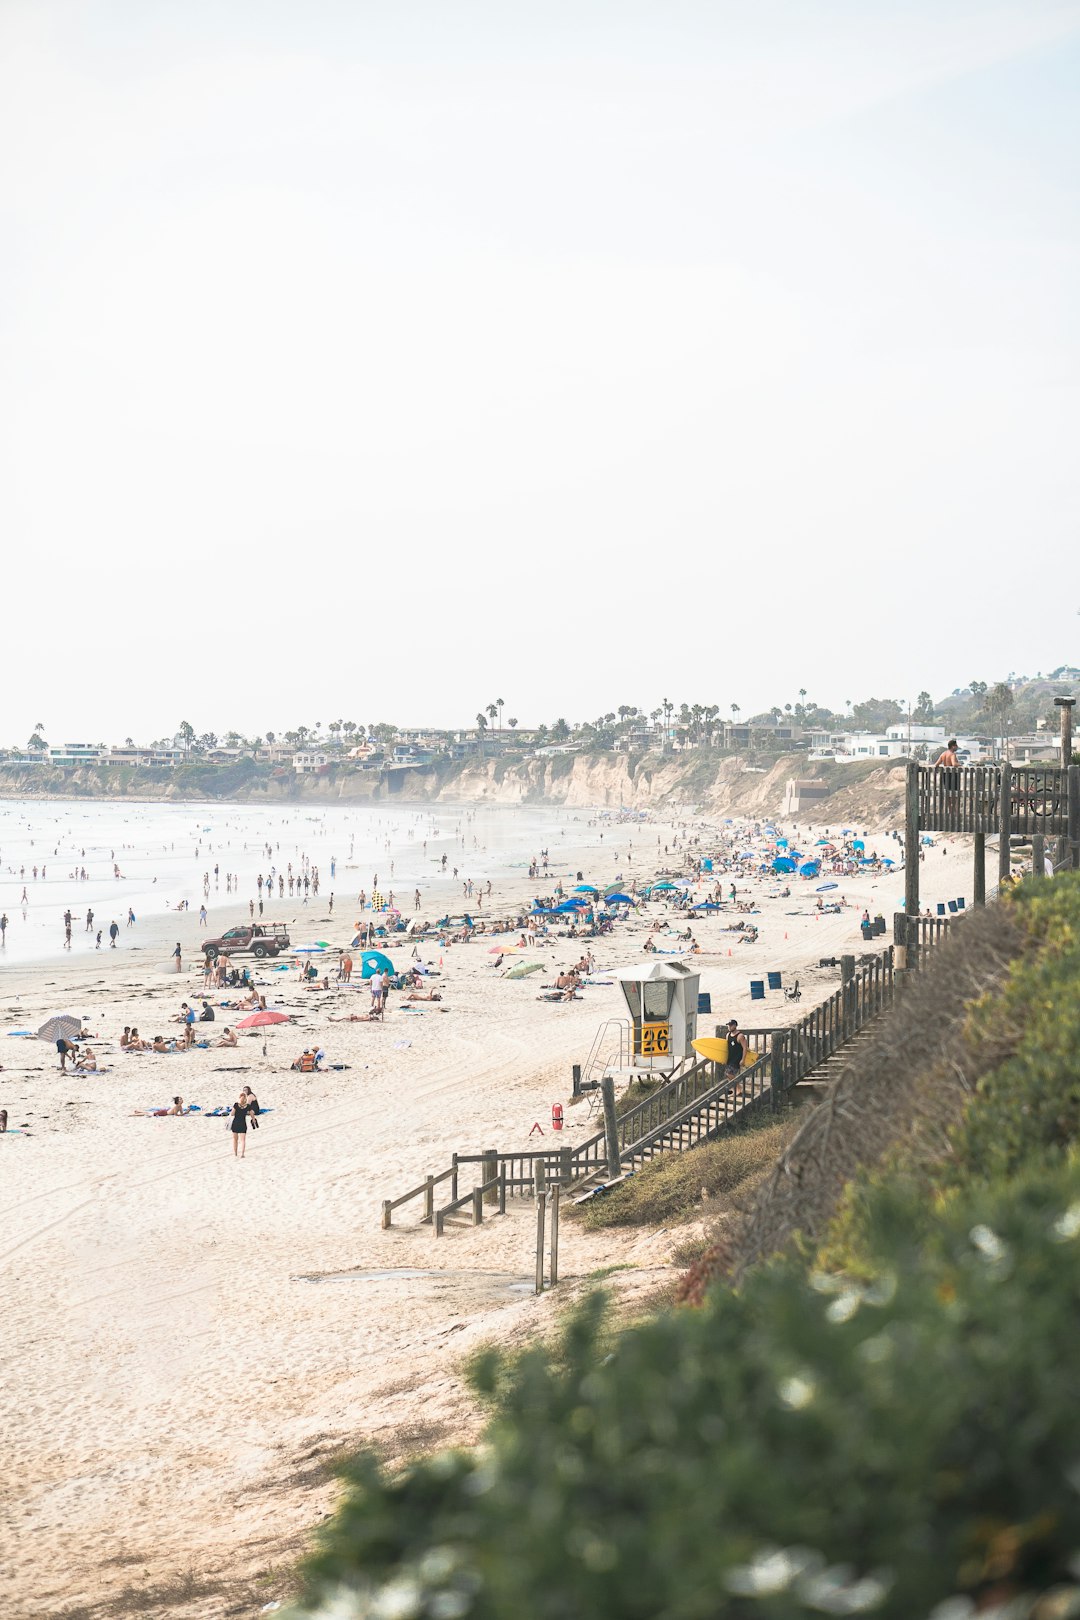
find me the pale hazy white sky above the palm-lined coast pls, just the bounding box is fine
[0,0,1080,742]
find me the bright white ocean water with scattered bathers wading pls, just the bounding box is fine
[0,799,656,964]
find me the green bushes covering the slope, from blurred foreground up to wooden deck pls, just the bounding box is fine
[289,878,1080,1620]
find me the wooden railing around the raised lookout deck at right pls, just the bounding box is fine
[905,765,1080,835]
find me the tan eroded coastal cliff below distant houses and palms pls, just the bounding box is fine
[0,750,904,821]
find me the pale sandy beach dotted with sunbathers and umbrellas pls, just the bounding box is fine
[0,812,970,1617]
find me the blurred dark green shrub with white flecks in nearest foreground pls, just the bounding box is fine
[293,1166,1080,1620]
